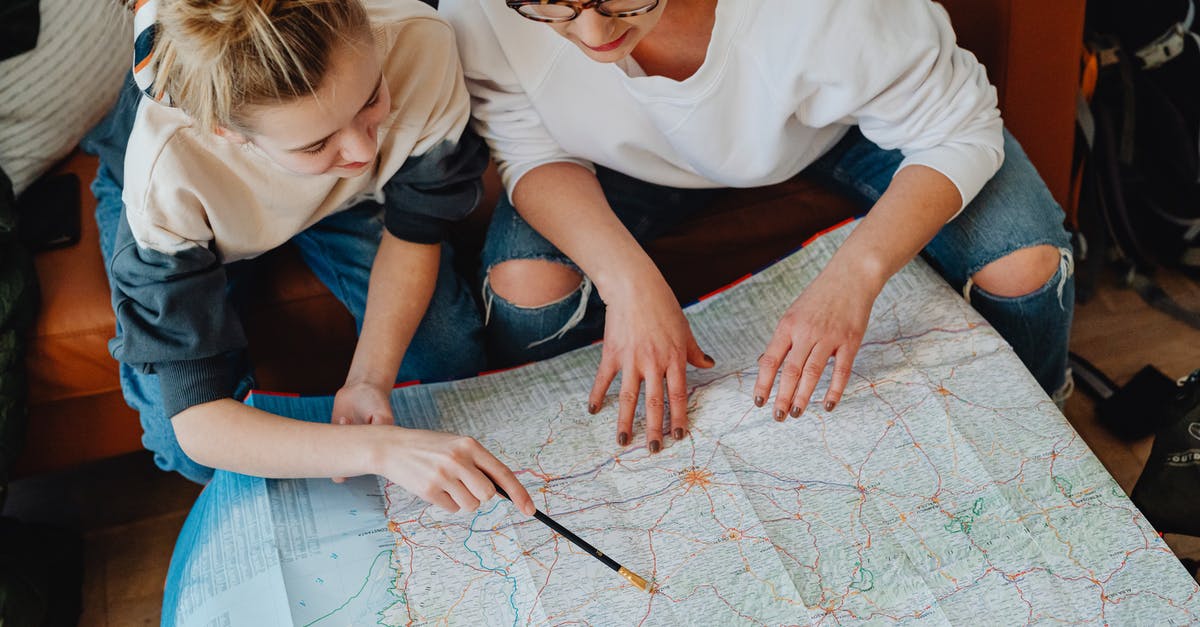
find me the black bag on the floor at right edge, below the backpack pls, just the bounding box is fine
[1129,370,1200,536]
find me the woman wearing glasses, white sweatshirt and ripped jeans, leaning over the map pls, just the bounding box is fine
[440,0,1073,452]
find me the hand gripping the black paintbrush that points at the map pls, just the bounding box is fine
[380,426,534,516]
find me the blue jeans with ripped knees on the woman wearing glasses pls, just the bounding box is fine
[482,129,1075,395]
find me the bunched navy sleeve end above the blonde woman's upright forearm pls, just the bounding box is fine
[384,129,488,244]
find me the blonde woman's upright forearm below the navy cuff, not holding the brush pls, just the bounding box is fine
[346,231,442,388]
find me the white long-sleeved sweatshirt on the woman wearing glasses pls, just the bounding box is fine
[439,0,1003,210]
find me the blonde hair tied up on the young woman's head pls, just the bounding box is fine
[154,0,370,132]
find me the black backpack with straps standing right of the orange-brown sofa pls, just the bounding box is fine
[1075,0,1200,317]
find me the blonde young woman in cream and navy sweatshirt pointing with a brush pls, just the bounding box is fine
[88,0,533,513]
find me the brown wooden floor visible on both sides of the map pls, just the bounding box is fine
[5,265,1200,626]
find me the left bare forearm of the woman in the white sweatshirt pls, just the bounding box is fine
[512,162,666,297]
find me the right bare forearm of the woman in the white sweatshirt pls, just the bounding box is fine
[828,166,962,293]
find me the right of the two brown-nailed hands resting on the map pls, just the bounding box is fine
[754,264,878,422]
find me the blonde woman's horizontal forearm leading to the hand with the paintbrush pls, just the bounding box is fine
[172,399,386,478]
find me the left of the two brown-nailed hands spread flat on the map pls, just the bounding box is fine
[588,276,714,453]
